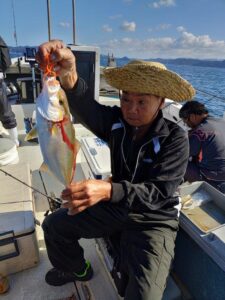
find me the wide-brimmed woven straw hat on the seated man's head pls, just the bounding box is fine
[104,60,195,101]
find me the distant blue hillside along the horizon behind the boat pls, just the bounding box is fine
[9,46,225,68]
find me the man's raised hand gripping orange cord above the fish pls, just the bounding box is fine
[36,40,78,89]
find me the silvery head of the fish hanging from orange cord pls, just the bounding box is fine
[36,77,68,122]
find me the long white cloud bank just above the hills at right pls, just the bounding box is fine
[99,31,225,59]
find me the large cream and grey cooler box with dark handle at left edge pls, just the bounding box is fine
[0,164,39,275]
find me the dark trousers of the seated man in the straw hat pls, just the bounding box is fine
[42,202,178,300]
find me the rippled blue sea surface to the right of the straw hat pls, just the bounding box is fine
[163,64,225,117]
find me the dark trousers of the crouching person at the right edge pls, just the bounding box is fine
[184,162,225,193]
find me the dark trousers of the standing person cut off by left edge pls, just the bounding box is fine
[0,79,17,129]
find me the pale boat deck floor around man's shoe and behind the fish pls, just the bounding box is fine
[1,136,118,300]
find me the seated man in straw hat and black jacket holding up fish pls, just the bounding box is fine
[37,40,195,300]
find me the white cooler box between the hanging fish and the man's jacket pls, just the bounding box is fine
[81,136,111,179]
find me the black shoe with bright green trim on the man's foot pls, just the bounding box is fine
[45,261,93,286]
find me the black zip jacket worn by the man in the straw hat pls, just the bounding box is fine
[67,79,189,220]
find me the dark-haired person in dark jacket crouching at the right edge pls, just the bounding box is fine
[179,101,225,193]
